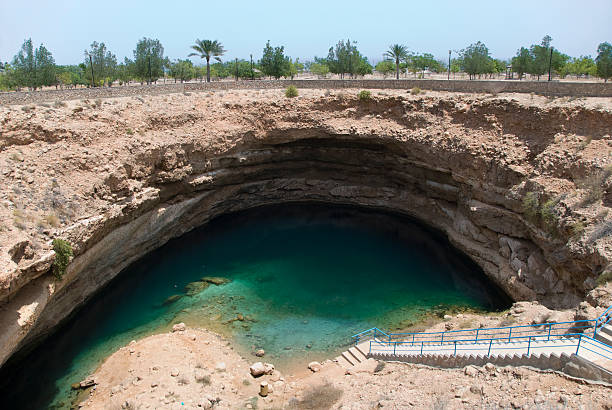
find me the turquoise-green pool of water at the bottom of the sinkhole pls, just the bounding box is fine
[0,205,509,407]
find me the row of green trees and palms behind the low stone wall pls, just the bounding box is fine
[0,36,612,90]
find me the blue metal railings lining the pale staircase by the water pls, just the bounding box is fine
[353,306,612,360]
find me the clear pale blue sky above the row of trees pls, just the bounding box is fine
[0,0,612,64]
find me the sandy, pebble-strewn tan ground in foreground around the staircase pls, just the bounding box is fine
[79,302,612,409]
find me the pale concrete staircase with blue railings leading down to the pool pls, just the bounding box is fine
[344,306,612,383]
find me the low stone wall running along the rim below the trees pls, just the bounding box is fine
[0,80,612,105]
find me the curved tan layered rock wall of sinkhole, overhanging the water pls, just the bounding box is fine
[0,90,612,368]
